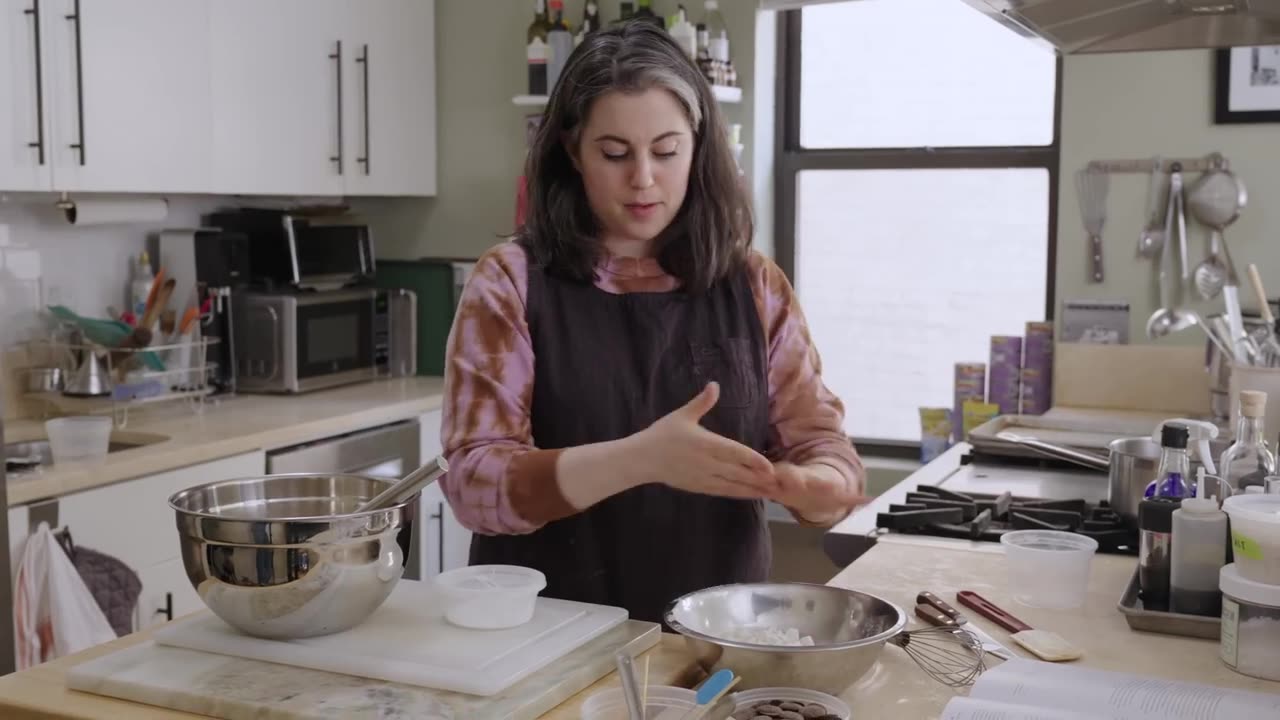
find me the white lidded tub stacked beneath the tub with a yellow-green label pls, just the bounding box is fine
[1219,564,1280,680]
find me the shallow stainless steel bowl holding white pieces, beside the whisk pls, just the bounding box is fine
[666,583,906,694]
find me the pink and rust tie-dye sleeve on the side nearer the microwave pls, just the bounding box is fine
[439,242,573,534]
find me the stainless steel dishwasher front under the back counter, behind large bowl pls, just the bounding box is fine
[266,420,422,580]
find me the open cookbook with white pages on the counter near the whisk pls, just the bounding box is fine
[941,659,1280,720]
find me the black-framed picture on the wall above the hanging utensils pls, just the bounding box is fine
[1213,45,1280,124]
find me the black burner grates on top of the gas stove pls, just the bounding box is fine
[876,484,1138,555]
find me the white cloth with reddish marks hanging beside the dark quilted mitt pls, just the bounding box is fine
[13,523,115,670]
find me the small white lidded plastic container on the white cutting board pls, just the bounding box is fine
[435,565,547,630]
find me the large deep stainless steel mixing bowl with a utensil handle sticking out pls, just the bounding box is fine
[169,474,420,639]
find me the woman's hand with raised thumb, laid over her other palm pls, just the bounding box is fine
[626,383,780,498]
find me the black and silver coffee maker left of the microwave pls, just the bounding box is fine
[157,228,252,393]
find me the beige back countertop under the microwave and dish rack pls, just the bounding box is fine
[5,377,444,506]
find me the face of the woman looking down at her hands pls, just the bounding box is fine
[573,88,694,242]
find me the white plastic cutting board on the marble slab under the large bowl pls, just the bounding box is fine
[154,580,627,696]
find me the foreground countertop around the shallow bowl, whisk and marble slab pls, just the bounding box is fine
[0,536,1280,720]
